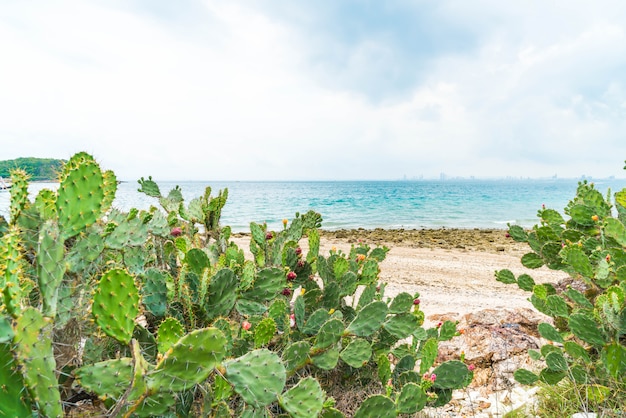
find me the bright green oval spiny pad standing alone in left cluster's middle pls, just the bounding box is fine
[91,269,139,344]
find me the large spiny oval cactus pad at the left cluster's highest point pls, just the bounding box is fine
[56,161,104,240]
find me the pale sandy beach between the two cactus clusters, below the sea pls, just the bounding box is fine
[234,229,567,321]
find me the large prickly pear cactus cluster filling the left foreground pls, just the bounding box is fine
[0,153,470,417]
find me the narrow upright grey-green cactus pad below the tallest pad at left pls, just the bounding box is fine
[37,221,65,318]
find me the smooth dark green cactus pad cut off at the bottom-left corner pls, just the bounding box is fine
[0,343,32,417]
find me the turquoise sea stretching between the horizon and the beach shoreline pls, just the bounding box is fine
[0,179,626,232]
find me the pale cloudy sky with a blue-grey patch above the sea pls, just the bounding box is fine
[0,0,626,181]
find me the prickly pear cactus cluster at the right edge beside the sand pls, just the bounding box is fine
[496,181,626,405]
